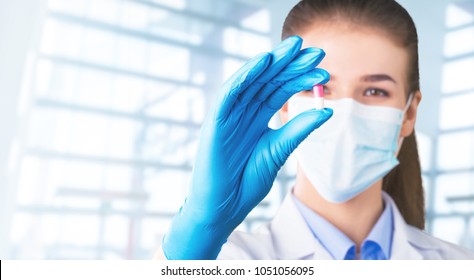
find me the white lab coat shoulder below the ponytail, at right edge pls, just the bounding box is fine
[406,225,474,260]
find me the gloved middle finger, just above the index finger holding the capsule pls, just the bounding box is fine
[256,48,326,101]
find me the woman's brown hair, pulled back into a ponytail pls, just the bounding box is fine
[282,0,425,229]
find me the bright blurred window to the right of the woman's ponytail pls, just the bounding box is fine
[434,1,474,249]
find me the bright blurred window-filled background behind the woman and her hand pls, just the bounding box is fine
[0,0,474,259]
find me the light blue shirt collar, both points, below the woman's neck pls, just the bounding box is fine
[292,191,393,260]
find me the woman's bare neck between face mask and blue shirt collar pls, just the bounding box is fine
[294,168,383,248]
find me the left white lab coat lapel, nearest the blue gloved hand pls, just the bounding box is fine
[270,193,332,260]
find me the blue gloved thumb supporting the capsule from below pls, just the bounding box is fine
[271,108,333,166]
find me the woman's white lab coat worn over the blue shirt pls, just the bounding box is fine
[218,193,474,260]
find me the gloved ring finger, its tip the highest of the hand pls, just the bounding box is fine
[240,36,303,106]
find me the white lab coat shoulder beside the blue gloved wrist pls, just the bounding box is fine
[218,224,276,260]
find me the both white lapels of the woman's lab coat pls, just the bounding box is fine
[270,192,429,260]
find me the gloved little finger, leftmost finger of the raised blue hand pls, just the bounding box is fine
[216,53,271,119]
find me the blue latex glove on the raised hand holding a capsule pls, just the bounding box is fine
[162,37,332,259]
